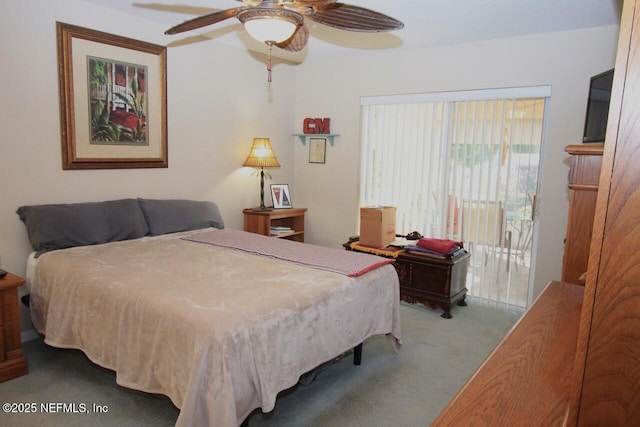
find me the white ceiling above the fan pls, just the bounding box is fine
[77,0,622,61]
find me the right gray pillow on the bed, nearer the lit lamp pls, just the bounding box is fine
[138,199,224,236]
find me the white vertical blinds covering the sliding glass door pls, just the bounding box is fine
[360,87,550,306]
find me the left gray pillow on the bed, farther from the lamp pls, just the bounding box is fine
[16,199,149,252]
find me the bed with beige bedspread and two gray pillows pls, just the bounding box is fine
[18,199,401,426]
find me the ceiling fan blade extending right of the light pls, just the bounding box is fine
[309,3,404,33]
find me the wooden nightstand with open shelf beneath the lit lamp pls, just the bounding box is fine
[242,208,307,242]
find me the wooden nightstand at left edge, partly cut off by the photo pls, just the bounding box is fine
[0,273,29,382]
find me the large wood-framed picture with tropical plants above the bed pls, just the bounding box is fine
[56,22,168,169]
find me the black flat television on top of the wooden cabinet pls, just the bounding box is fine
[582,69,613,143]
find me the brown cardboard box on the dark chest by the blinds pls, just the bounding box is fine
[360,206,396,246]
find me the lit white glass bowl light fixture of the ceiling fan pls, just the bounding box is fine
[236,7,304,44]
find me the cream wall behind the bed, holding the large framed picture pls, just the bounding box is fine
[0,0,295,330]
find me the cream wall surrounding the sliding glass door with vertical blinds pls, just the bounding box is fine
[292,26,618,296]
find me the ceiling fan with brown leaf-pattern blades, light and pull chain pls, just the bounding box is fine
[165,0,404,81]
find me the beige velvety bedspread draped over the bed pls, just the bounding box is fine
[30,232,400,426]
